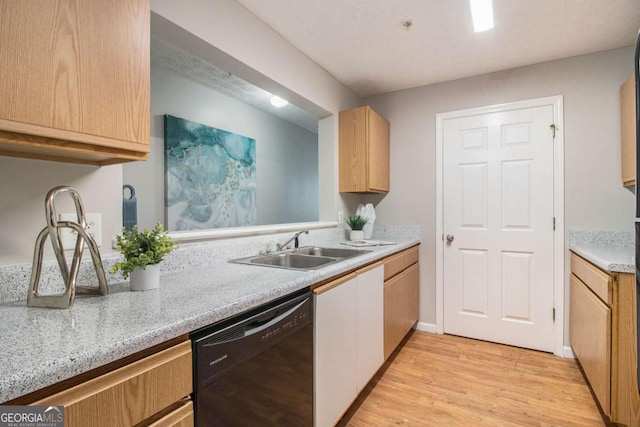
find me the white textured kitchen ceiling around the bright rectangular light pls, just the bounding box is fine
[237,0,640,97]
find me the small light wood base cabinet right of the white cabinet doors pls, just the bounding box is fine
[384,246,420,359]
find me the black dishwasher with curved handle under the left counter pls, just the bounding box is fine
[191,289,313,427]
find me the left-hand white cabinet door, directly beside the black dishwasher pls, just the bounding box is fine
[313,276,358,427]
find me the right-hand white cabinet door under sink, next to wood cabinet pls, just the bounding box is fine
[356,265,384,392]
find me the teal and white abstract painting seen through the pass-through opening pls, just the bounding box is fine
[164,115,257,231]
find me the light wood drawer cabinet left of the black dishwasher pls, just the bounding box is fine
[32,341,193,427]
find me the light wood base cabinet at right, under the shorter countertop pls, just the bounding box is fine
[569,253,640,426]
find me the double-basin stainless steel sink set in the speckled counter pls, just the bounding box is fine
[229,246,371,271]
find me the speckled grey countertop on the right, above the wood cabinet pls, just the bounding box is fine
[569,230,635,273]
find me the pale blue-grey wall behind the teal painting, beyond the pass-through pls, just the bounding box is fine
[123,62,318,228]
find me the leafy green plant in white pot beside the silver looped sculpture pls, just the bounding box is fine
[109,223,175,291]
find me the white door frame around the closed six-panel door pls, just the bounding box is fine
[435,95,567,356]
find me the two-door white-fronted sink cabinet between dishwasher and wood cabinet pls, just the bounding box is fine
[313,264,384,427]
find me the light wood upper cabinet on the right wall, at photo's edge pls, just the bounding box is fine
[620,75,636,187]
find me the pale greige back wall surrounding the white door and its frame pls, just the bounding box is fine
[365,47,634,332]
